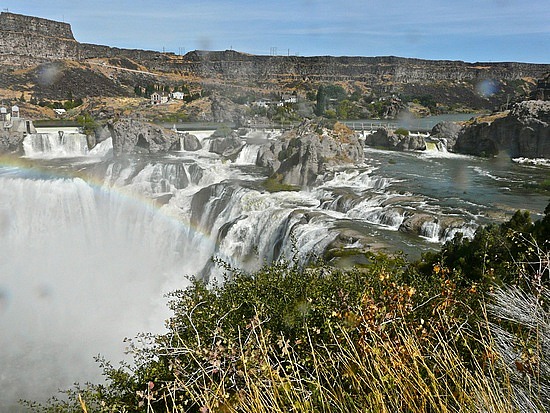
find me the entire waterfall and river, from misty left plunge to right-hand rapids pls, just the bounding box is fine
[0,123,549,406]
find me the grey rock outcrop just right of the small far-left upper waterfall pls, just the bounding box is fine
[107,119,180,156]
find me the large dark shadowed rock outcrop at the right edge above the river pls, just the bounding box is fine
[454,100,550,158]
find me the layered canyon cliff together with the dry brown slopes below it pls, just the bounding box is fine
[0,12,550,109]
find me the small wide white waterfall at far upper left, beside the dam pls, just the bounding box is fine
[23,132,88,158]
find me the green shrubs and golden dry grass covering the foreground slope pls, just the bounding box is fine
[26,205,550,413]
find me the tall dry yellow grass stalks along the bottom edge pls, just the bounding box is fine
[148,314,516,413]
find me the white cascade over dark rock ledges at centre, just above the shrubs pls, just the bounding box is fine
[211,188,336,270]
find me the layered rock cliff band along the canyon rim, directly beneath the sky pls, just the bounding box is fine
[0,12,550,85]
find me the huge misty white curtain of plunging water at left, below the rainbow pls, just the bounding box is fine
[0,178,213,406]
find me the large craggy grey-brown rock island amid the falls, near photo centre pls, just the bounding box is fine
[257,121,363,187]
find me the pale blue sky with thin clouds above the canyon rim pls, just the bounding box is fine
[0,0,550,63]
